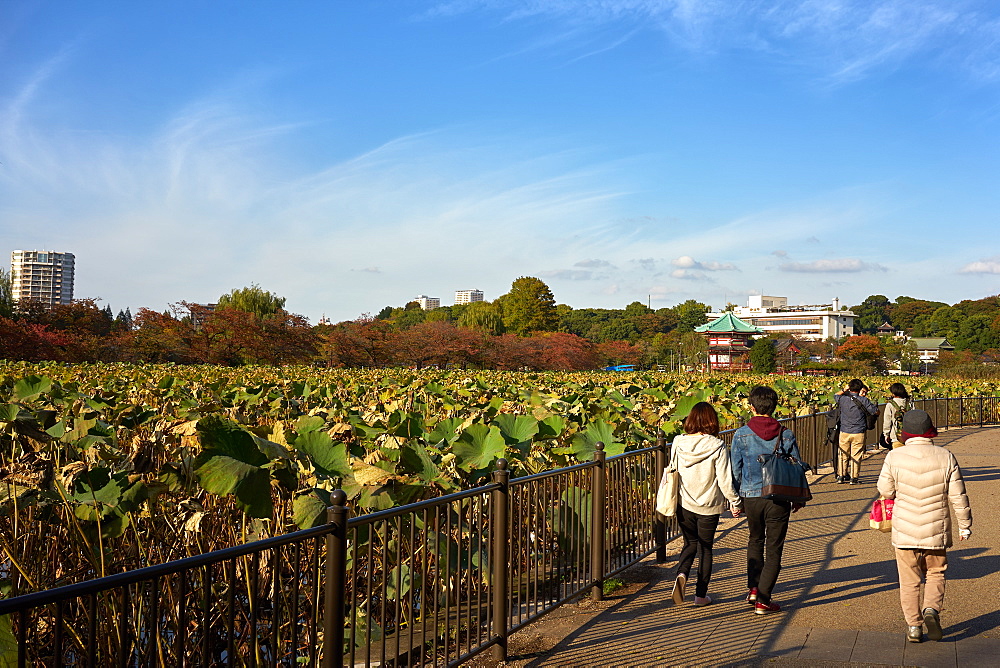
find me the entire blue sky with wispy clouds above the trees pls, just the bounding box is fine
[0,0,1000,322]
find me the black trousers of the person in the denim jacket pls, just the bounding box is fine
[743,498,792,603]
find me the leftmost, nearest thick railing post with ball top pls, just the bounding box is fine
[322,489,348,668]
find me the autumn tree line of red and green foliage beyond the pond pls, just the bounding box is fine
[0,271,1000,370]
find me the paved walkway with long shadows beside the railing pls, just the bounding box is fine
[510,429,1000,668]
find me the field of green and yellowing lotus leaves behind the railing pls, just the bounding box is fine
[0,361,997,595]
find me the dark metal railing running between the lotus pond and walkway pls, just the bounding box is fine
[0,397,1000,667]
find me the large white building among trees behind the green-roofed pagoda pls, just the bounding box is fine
[708,295,855,341]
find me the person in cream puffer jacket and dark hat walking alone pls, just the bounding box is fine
[878,410,972,642]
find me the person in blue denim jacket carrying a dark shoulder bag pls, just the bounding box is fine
[732,385,801,615]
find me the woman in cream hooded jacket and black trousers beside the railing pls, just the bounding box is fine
[670,401,741,605]
